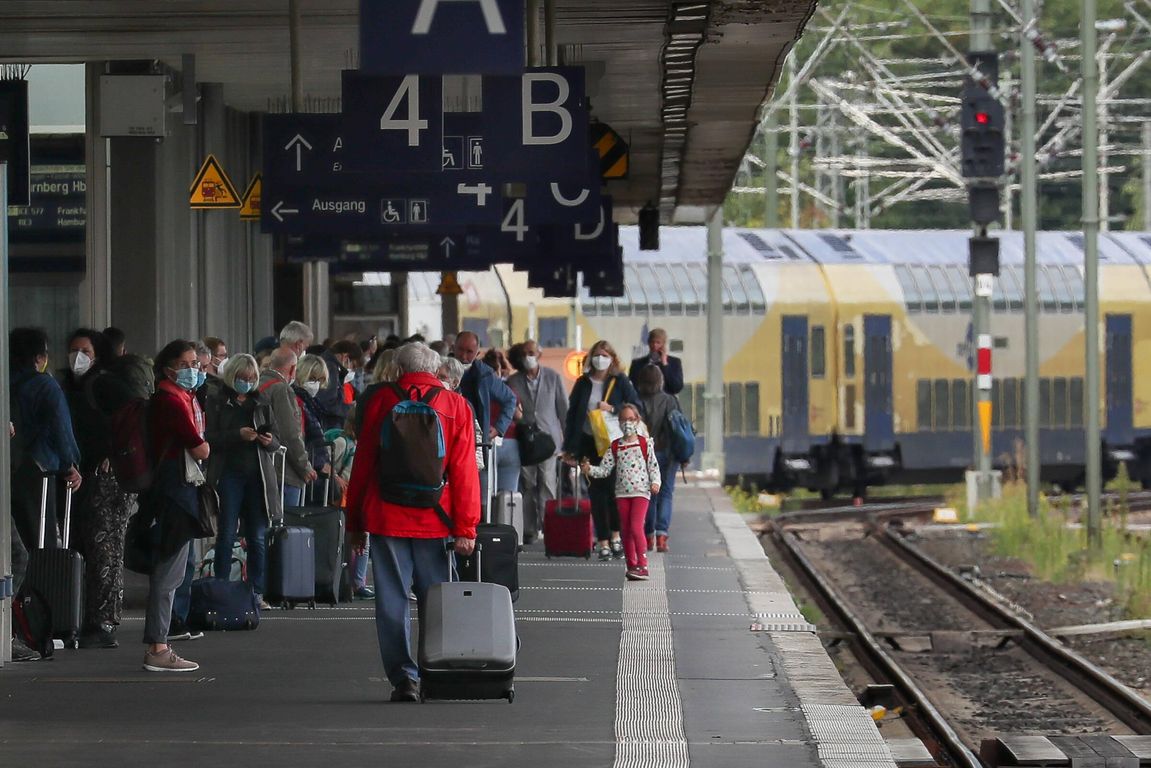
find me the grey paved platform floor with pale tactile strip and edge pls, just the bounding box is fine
[0,484,897,768]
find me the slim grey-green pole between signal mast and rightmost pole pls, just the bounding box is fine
[1019,0,1042,517]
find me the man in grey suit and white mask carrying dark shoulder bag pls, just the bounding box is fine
[508,341,567,543]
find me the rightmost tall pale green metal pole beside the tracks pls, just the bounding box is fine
[1080,0,1103,548]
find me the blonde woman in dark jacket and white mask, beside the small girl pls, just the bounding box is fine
[563,339,639,560]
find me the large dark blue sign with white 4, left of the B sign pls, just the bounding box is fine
[343,70,443,173]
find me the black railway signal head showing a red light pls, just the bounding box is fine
[959,53,1006,178]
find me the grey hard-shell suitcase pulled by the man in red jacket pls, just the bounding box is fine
[418,543,518,704]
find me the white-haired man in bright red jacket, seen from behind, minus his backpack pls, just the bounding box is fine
[348,342,480,701]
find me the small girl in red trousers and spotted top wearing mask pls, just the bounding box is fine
[580,403,661,581]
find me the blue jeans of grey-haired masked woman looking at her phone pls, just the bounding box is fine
[213,469,268,594]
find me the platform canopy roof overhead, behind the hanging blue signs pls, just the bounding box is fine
[0,0,815,222]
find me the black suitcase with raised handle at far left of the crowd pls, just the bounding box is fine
[24,474,84,648]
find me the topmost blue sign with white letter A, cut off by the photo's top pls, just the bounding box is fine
[360,0,526,75]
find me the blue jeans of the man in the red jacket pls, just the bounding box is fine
[371,534,453,685]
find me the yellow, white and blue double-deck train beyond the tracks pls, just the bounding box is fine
[407,227,1151,495]
